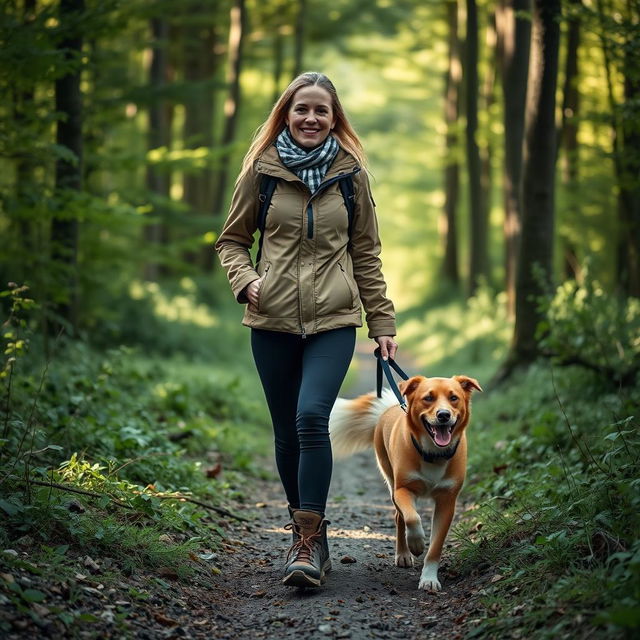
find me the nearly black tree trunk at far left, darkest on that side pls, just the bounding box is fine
[51,0,84,328]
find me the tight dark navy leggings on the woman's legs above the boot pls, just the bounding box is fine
[251,327,356,513]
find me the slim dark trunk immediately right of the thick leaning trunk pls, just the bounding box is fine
[558,0,582,278]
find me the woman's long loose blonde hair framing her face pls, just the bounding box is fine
[238,71,367,180]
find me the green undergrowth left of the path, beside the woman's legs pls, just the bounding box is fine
[0,286,269,603]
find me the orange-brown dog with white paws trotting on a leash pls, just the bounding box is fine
[329,376,482,591]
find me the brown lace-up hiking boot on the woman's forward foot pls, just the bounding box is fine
[282,510,331,587]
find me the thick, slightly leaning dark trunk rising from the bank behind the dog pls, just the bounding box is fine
[511,0,561,364]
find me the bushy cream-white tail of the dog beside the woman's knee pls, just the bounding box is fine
[329,389,398,458]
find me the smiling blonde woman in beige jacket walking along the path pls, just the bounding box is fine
[216,73,397,586]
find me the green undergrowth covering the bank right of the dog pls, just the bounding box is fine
[452,283,640,639]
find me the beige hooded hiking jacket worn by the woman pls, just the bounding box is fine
[215,146,396,338]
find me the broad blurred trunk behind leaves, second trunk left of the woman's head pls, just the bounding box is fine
[183,16,216,271]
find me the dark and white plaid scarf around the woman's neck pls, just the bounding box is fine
[276,128,339,193]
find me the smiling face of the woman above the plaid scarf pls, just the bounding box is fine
[286,85,336,149]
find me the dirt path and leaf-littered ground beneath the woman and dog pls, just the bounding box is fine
[0,344,495,640]
